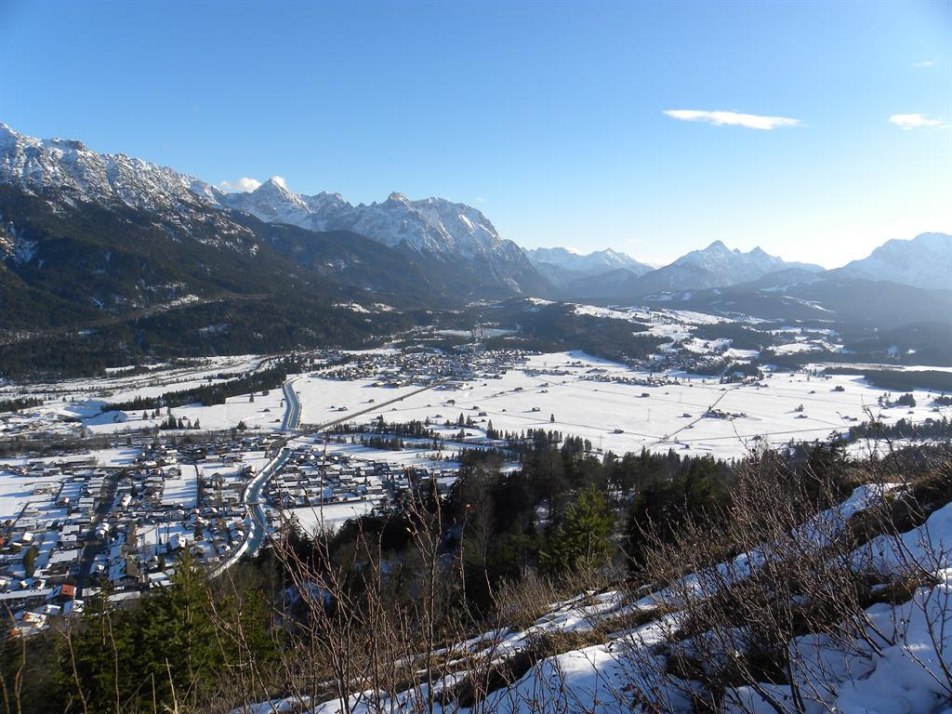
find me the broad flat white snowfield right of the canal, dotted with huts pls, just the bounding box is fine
[296,352,952,458]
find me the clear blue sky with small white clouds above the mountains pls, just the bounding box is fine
[0,0,952,267]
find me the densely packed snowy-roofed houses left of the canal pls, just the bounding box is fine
[0,435,294,635]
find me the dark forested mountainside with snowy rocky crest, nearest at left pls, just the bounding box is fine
[0,124,437,308]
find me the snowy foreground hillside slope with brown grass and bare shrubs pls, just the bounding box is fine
[255,468,952,714]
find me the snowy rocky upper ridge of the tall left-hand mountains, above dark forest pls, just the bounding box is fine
[0,124,548,297]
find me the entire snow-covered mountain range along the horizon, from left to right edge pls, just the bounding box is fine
[0,123,952,299]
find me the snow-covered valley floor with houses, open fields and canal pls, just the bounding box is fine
[0,316,939,634]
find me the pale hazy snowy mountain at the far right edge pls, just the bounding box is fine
[832,233,952,290]
